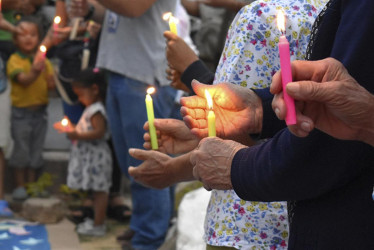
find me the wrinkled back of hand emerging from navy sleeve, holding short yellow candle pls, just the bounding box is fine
[190,137,246,191]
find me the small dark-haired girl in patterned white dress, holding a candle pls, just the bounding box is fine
[55,68,112,236]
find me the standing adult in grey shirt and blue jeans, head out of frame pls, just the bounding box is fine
[70,0,181,249]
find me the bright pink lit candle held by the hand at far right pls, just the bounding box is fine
[277,11,296,125]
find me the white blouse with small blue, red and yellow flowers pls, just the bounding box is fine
[204,0,327,249]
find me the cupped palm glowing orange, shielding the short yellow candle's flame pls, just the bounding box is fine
[181,81,262,144]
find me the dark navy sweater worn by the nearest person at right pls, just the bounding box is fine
[231,0,374,250]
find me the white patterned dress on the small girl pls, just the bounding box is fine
[67,102,112,192]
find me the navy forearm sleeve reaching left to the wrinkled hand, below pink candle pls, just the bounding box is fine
[231,129,374,201]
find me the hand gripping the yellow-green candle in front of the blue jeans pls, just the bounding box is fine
[143,119,199,154]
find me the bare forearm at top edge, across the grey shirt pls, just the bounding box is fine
[97,0,156,17]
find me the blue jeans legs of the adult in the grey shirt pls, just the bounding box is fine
[115,78,177,249]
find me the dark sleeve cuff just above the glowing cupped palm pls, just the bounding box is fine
[181,60,214,92]
